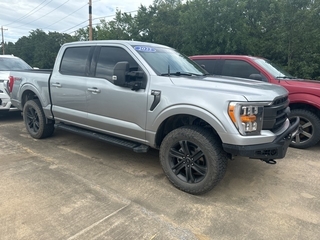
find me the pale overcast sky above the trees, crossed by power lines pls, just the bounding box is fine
[0,0,154,42]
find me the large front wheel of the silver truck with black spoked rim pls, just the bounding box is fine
[160,126,227,194]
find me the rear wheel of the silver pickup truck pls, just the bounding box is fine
[23,99,54,139]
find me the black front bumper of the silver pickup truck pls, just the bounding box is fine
[222,117,300,160]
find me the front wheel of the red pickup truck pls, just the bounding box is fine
[289,109,320,149]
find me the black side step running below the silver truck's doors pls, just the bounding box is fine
[54,123,149,153]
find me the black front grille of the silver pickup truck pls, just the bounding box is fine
[262,96,289,132]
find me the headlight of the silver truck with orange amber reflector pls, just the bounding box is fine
[228,102,263,135]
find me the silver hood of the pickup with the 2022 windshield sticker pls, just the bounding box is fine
[170,76,288,102]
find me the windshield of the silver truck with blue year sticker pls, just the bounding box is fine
[133,46,208,76]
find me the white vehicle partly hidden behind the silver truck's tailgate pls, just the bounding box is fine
[0,55,31,113]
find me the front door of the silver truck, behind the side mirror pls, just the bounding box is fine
[87,46,147,141]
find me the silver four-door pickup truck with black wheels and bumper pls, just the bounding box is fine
[8,40,299,194]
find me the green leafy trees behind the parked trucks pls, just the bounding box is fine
[2,0,320,80]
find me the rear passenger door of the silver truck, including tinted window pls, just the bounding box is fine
[50,46,94,125]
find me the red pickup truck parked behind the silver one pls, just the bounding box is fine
[190,55,320,148]
